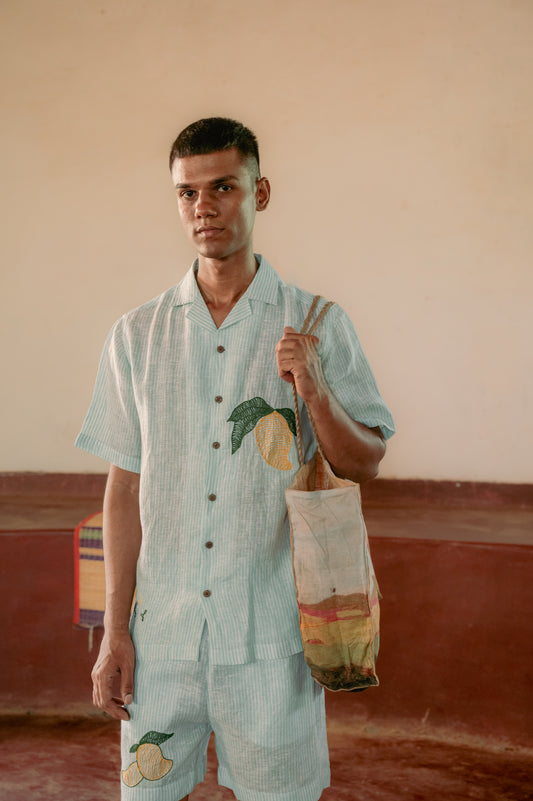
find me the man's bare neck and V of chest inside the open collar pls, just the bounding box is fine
[196,253,258,328]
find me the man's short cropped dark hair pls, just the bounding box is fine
[169,117,261,177]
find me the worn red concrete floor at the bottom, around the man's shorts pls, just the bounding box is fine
[0,716,533,801]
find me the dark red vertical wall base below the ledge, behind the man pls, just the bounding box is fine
[0,531,533,745]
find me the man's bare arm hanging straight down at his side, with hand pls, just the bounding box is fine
[92,465,142,720]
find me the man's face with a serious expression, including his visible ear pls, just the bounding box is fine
[172,148,270,260]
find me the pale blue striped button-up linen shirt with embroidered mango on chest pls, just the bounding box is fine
[76,256,394,665]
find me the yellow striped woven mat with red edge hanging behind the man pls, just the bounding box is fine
[74,512,105,629]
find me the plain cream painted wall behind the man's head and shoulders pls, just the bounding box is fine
[0,0,533,482]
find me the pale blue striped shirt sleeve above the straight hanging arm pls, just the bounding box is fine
[75,318,142,473]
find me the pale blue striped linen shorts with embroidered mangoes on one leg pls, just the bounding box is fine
[121,624,330,801]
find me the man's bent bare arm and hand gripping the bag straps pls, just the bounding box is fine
[276,327,386,483]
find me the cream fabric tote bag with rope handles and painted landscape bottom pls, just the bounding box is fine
[285,296,379,692]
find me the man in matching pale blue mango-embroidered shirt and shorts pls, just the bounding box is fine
[77,118,394,801]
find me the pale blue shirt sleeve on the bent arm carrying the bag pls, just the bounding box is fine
[317,305,395,439]
